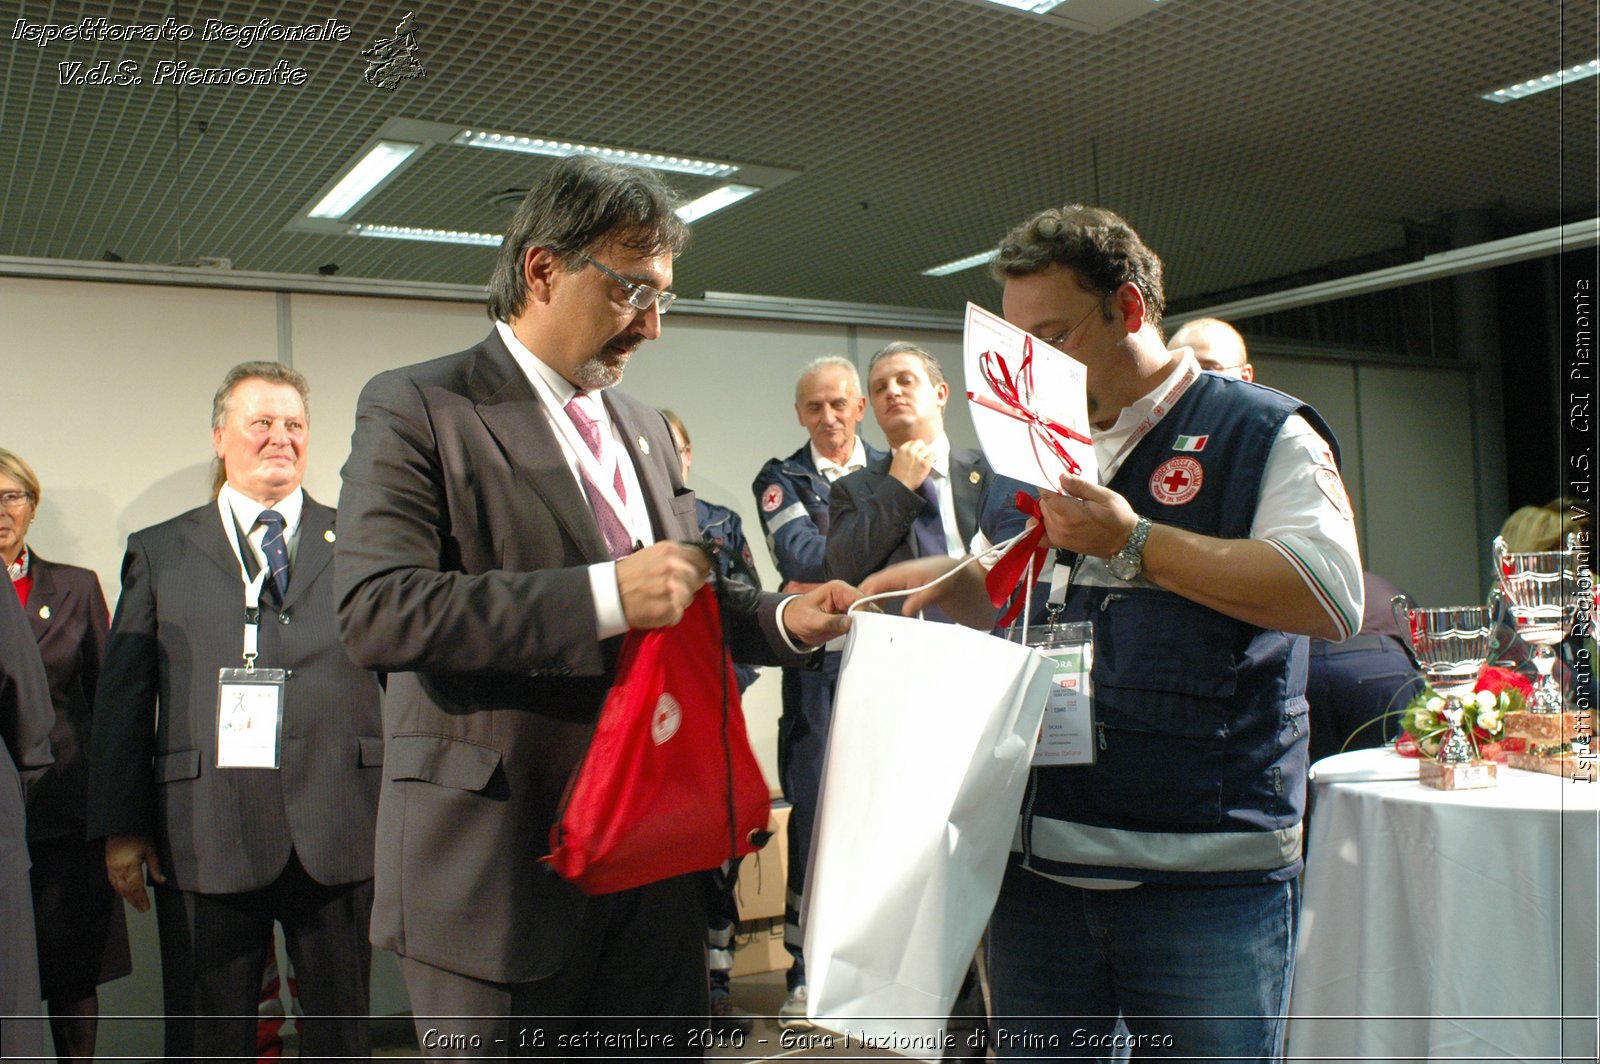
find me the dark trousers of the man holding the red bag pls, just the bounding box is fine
[400,874,710,1059]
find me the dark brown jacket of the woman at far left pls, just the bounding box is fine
[24,552,110,838]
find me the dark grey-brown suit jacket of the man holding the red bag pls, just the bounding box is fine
[336,333,803,982]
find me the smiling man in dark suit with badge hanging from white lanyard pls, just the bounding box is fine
[90,362,382,1059]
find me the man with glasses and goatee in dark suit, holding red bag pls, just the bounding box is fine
[338,157,854,1058]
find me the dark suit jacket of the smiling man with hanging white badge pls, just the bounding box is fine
[90,496,382,894]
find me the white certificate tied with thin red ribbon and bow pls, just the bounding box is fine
[962,304,1099,491]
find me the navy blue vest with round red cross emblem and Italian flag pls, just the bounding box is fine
[1022,373,1338,883]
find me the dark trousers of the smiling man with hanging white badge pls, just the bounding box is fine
[155,853,373,1061]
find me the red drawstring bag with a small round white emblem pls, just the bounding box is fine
[541,586,771,894]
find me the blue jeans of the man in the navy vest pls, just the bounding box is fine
[989,866,1299,1061]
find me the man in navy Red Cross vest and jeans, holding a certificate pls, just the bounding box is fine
[862,205,1362,1059]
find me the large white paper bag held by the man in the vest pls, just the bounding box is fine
[802,613,1051,1061]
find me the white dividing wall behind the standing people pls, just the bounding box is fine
[0,277,1493,779]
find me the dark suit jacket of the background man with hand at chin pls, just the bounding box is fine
[827,446,990,584]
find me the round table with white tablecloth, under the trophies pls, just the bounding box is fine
[1288,750,1600,1062]
